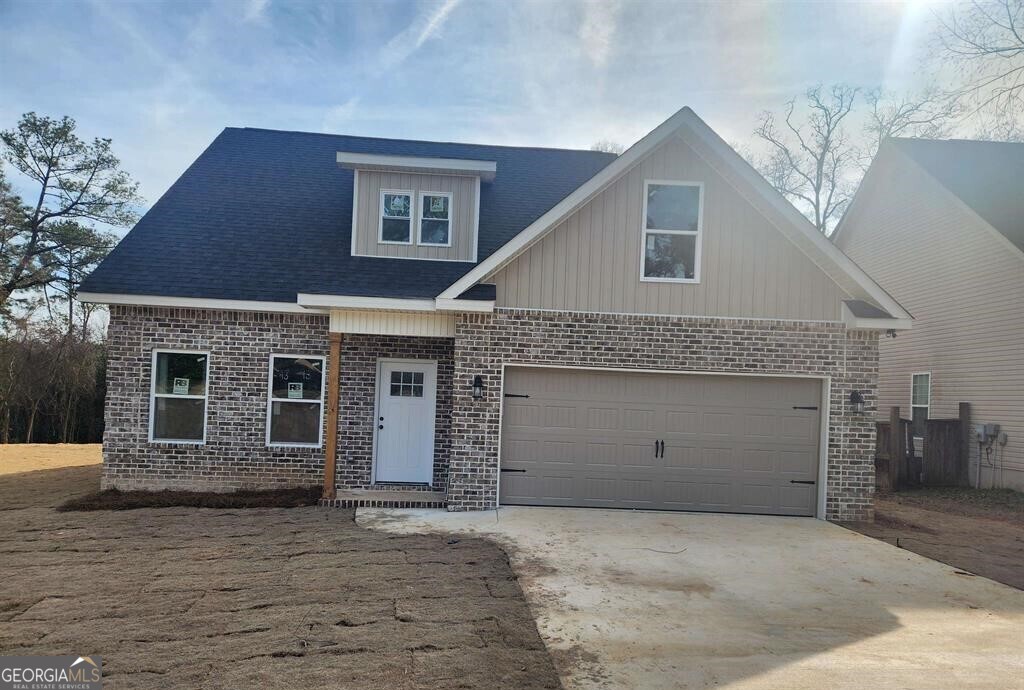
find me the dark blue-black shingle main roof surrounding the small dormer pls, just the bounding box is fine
[82,128,615,302]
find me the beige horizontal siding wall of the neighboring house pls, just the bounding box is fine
[837,152,1024,489]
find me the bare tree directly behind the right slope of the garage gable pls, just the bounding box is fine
[754,84,858,234]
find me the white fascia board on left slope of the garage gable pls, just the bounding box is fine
[438,107,691,299]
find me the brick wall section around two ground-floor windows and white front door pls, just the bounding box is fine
[102,306,454,490]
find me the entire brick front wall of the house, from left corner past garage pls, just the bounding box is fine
[103,306,878,519]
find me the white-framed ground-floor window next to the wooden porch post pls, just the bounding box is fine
[266,354,324,447]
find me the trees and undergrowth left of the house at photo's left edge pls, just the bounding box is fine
[0,113,141,443]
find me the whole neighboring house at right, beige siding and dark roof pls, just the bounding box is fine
[834,139,1024,490]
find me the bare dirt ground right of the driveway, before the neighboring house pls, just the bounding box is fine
[844,489,1024,590]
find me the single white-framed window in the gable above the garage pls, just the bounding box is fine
[640,180,703,283]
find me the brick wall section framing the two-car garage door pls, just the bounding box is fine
[449,309,878,520]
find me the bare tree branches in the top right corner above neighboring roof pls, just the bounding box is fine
[938,0,1024,120]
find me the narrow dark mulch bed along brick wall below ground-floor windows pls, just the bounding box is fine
[56,486,323,513]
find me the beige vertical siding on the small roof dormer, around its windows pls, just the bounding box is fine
[352,170,478,261]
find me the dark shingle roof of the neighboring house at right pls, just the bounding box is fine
[892,139,1024,251]
